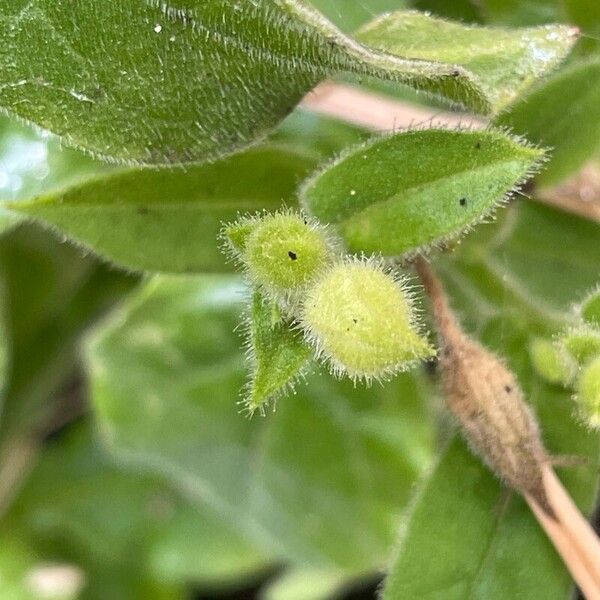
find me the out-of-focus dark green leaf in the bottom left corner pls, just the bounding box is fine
[7,423,267,598]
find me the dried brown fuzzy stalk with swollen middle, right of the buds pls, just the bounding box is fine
[416,258,600,600]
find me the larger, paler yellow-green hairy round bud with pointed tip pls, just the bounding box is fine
[301,260,435,381]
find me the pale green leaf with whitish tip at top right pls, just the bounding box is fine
[357,12,576,110]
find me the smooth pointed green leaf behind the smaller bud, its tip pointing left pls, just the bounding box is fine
[6,145,314,272]
